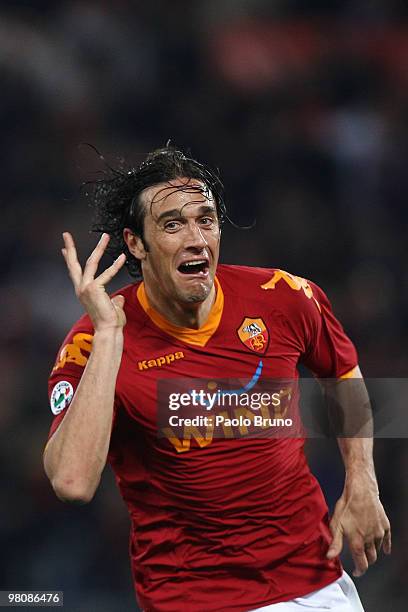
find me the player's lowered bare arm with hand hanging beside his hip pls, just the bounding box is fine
[327,369,391,577]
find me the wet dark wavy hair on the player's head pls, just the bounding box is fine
[87,144,228,278]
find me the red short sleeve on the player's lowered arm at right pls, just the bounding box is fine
[301,282,358,378]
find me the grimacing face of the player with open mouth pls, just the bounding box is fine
[134,178,220,304]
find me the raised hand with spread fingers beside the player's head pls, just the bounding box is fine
[61,232,126,332]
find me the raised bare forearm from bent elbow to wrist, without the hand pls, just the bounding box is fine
[44,329,123,502]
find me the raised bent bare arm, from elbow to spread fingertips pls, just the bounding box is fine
[44,233,126,503]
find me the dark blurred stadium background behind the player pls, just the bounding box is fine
[0,0,408,612]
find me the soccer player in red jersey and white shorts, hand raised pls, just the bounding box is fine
[44,146,391,612]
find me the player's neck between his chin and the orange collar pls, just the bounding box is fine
[145,283,216,329]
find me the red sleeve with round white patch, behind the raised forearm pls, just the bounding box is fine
[48,318,93,438]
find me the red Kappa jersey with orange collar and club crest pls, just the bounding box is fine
[49,265,357,612]
